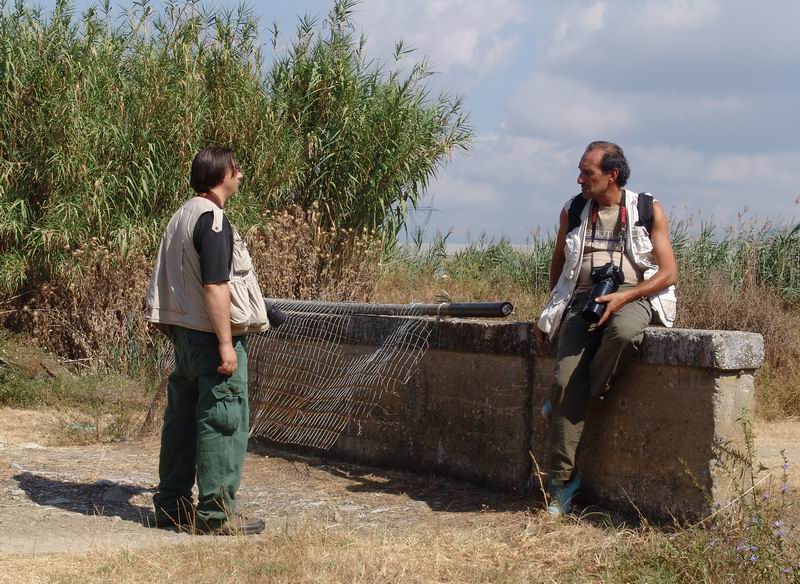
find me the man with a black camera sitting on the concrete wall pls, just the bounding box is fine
[534,142,677,515]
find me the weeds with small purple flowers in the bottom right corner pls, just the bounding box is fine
[605,421,800,583]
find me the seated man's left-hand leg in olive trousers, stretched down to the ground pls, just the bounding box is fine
[549,294,600,481]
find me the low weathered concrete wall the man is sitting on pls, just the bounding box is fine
[250,316,764,518]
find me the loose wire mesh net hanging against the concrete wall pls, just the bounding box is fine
[248,300,431,449]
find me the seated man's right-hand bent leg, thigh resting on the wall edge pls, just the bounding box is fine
[589,298,653,397]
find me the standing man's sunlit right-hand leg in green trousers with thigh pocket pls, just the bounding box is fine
[192,337,250,529]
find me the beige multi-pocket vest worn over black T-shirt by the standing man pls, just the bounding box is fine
[145,197,269,335]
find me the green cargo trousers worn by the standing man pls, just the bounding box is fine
[153,326,250,529]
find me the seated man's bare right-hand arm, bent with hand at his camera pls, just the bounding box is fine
[595,202,678,326]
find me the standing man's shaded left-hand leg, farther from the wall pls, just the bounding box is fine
[153,327,197,527]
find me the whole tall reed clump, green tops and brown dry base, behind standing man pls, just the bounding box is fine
[0,0,471,375]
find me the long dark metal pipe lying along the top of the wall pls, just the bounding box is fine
[265,298,514,318]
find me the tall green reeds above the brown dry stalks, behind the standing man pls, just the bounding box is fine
[0,0,471,292]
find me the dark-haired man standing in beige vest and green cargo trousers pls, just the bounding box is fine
[147,146,269,535]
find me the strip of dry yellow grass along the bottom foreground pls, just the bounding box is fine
[0,514,620,584]
